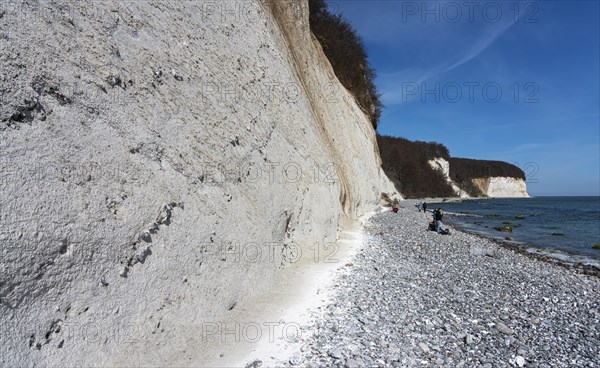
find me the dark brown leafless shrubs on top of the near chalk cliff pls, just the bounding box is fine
[308,0,382,128]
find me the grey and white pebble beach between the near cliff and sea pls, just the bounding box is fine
[262,201,600,368]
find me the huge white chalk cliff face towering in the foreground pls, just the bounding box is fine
[0,0,394,367]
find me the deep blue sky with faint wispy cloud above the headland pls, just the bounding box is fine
[329,0,600,196]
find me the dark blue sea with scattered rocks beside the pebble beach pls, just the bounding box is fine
[428,197,600,267]
